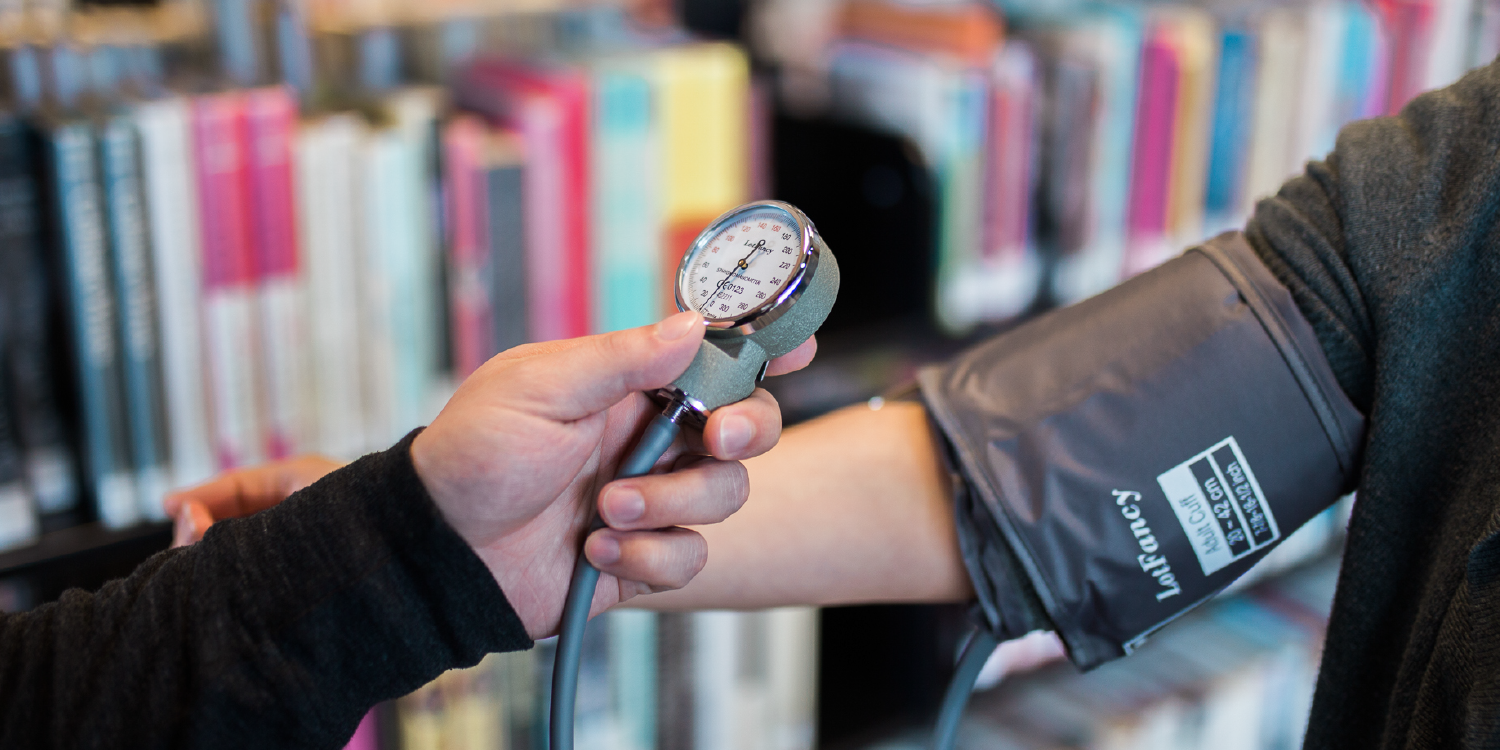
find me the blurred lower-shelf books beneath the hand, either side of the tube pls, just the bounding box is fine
[347,609,818,750]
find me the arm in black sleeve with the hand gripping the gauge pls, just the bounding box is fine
[0,314,812,747]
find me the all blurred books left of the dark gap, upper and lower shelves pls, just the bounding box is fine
[0,3,816,750]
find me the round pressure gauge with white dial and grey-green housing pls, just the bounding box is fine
[657,201,839,423]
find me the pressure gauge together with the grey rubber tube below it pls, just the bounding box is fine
[551,201,839,750]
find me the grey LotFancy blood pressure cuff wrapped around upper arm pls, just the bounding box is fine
[918,234,1364,669]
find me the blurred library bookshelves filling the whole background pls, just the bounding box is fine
[0,0,1482,750]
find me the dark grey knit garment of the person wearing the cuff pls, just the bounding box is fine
[1247,57,1500,750]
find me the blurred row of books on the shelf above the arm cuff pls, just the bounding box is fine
[753,0,1500,332]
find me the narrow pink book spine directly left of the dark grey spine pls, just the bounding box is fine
[443,117,494,378]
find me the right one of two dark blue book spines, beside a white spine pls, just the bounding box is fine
[99,116,168,521]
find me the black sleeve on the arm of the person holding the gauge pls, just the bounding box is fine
[0,432,531,749]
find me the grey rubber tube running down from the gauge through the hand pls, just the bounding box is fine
[549,404,683,750]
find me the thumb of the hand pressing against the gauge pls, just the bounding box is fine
[515,311,704,422]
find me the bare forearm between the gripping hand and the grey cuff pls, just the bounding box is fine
[633,402,974,609]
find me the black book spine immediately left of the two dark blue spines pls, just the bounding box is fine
[0,120,78,513]
